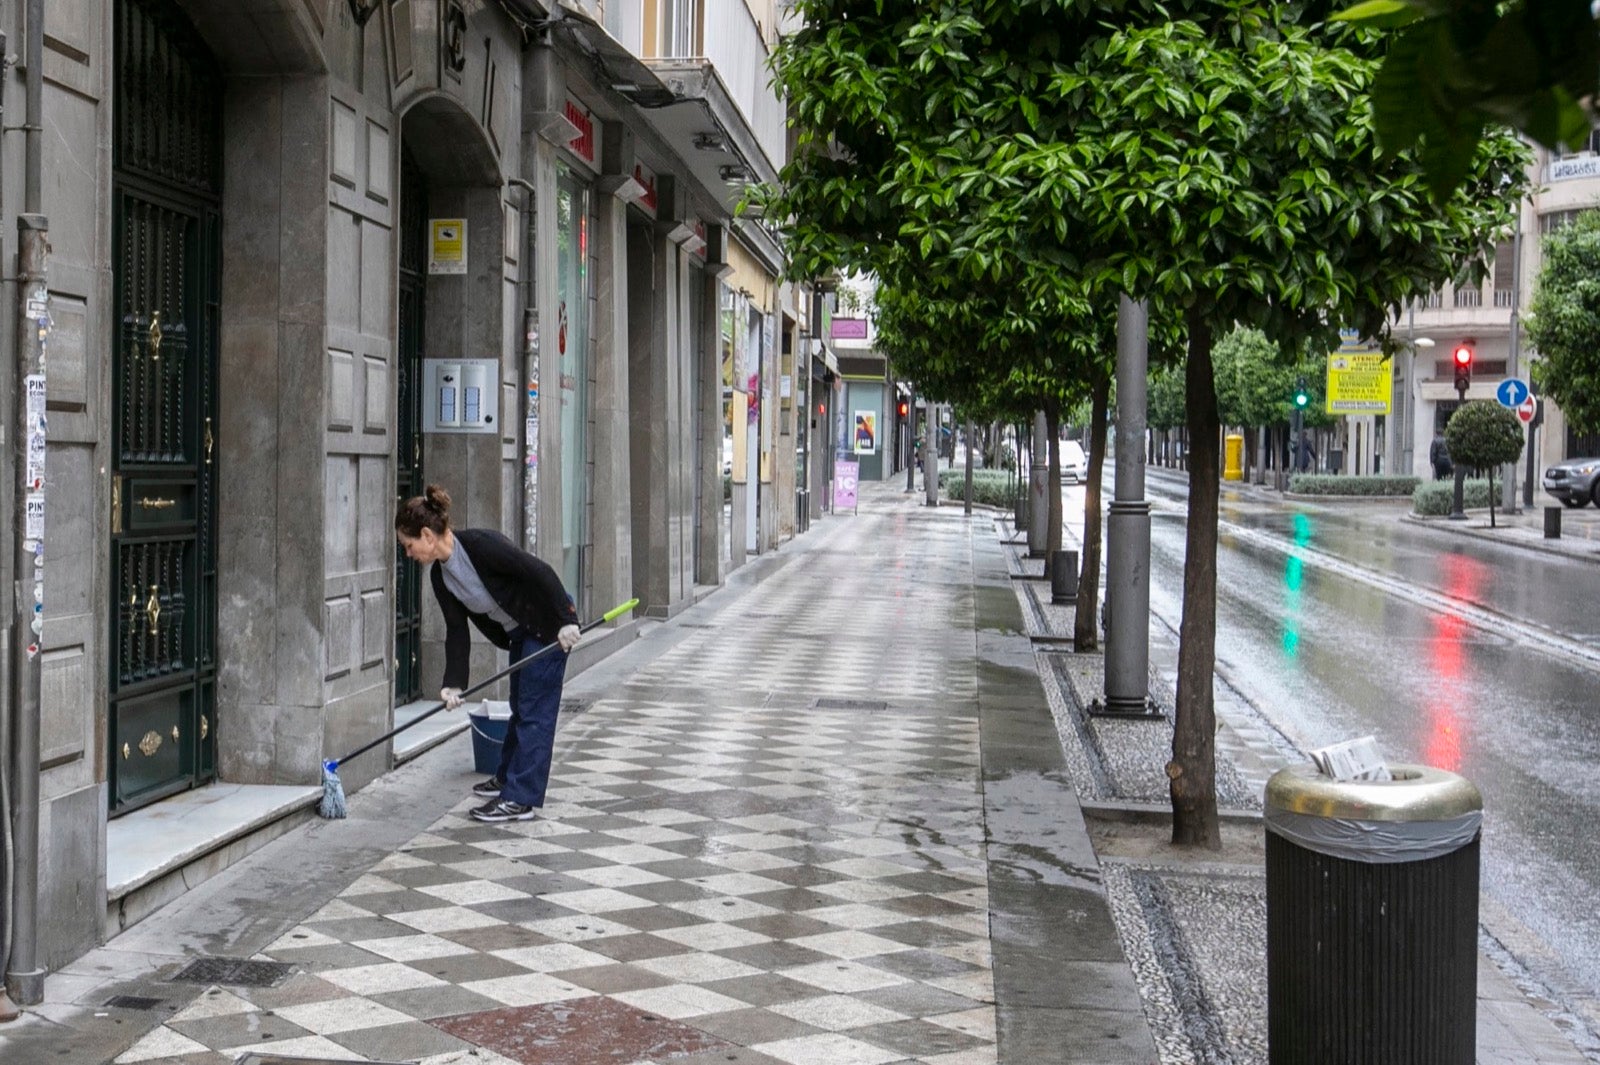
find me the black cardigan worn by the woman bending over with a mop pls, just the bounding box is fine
[429,529,578,688]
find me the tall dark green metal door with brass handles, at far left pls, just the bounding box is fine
[106,0,222,814]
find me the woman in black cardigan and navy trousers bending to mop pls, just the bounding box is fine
[395,485,581,822]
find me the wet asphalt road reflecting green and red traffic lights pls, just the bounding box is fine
[1107,475,1600,1031]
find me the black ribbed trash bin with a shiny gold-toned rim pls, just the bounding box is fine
[1266,766,1483,1065]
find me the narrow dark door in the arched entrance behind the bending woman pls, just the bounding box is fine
[395,146,427,704]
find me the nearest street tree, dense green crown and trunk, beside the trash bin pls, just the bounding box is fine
[768,0,1523,846]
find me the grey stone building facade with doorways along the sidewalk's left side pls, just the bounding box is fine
[0,0,822,966]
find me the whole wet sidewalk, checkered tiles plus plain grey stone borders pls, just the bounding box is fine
[0,486,1154,1065]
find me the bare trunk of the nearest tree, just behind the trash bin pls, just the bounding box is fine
[1166,310,1222,851]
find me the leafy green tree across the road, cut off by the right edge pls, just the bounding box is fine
[1523,211,1600,434]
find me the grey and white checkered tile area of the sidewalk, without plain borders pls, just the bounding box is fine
[117,498,995,1065]
